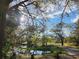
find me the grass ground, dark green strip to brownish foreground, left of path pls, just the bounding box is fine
[17,43,76,59]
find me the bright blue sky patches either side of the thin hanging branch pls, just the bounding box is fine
[47,11,78,25]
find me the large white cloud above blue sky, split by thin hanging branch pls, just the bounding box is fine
[38,0,77,18]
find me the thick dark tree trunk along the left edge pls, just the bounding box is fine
[0,0,10,59]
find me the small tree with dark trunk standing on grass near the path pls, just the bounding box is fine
[51,23,64,46]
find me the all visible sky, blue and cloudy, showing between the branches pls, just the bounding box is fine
[10,0,79,36]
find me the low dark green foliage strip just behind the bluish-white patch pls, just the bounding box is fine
[27,45,65,54]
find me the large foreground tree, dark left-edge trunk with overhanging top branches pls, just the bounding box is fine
[0,0,78,59]
